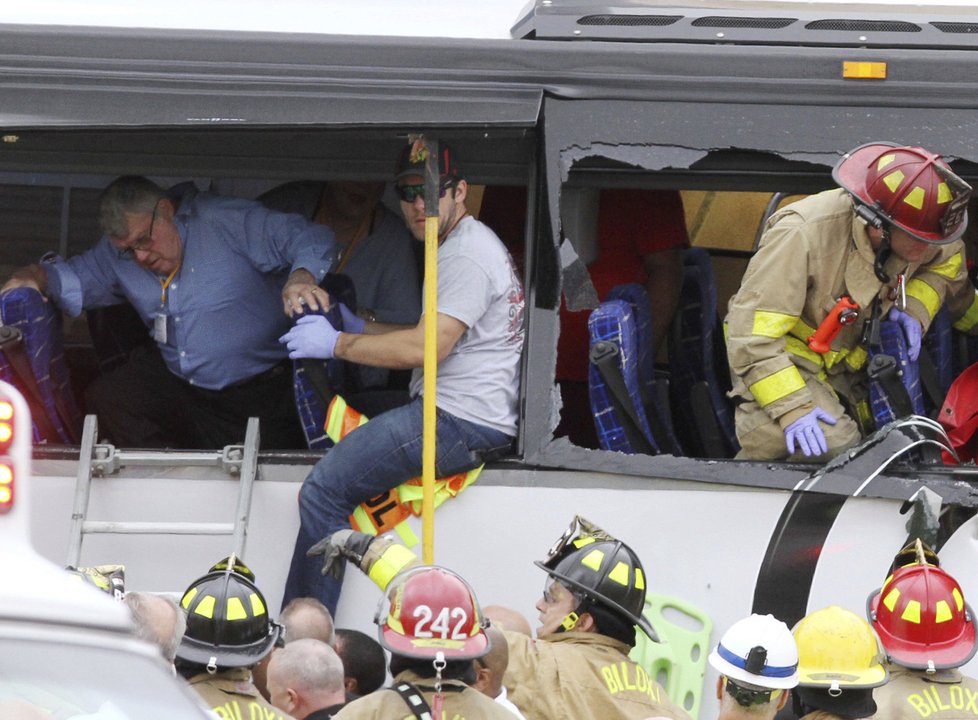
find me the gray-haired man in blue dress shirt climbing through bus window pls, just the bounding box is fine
[2,176,334,448]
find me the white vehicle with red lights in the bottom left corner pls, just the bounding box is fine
[0,382,211,720]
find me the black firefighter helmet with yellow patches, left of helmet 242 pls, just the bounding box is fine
[177,555,282,673]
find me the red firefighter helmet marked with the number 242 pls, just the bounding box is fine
[374,565,489,660]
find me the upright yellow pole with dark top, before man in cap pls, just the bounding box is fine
[421,139,441,565]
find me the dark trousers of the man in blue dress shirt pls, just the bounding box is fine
[85,346,305,450]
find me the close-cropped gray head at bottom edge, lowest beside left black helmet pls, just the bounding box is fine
[268,638,346,718]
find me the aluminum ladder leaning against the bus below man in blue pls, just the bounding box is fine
[67,415,260,567]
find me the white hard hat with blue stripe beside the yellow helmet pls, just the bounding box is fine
[709,615,798,690]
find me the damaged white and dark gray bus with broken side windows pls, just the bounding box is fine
[0,0,978,718]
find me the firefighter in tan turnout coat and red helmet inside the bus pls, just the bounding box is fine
[726,143,978,460]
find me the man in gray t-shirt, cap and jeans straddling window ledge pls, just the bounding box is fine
[282,145,524,613]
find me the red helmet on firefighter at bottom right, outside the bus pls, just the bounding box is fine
[867,563,975,671]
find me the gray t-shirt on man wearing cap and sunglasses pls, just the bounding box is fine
[411,217,524,436]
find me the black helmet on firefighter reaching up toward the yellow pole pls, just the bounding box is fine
[534,515,659,642]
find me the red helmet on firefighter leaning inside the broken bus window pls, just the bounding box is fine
[832,142,971,245]
